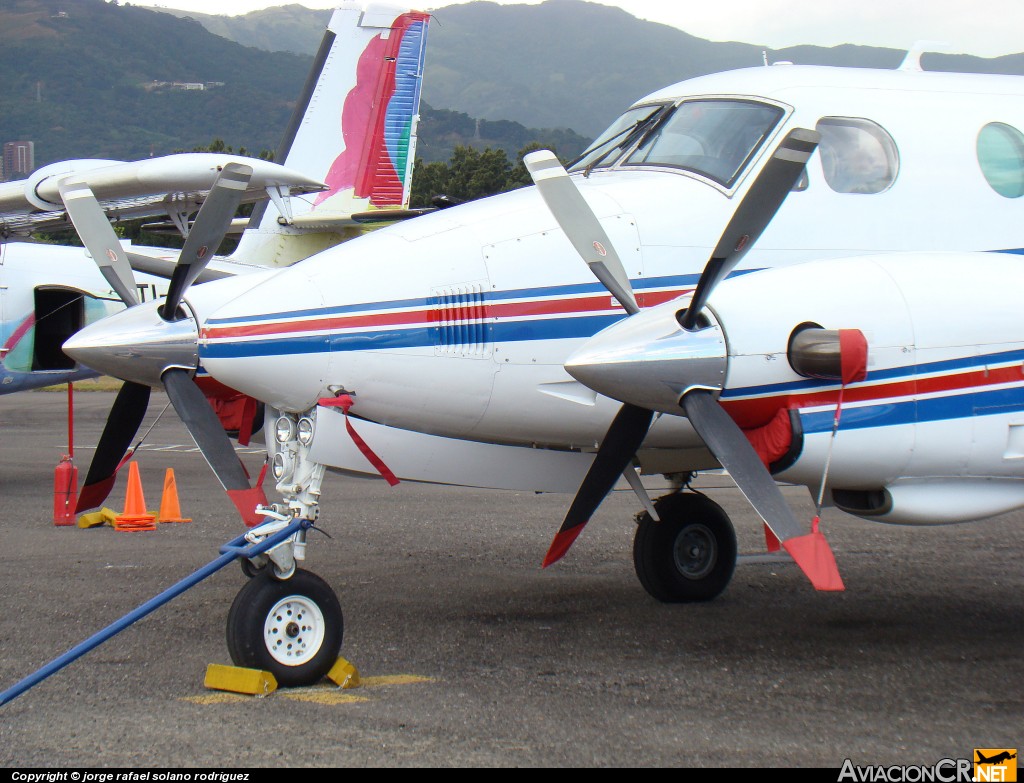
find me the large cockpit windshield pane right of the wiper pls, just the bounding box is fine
[625,100,783,187]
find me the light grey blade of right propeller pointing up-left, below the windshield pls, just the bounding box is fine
[522,149,640,315]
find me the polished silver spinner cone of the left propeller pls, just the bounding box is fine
[63,302,199,387]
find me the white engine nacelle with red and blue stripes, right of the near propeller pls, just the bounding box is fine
[711,253,1024,524]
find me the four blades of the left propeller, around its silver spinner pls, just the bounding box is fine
[60,163,263,523]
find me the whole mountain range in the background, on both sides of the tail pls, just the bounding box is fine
[6,0,1024,170]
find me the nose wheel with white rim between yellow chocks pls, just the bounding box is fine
[227,569,344,687]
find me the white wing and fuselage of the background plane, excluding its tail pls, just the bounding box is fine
[0,154,322,392]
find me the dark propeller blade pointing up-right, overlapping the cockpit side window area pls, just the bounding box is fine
[681,128,820,331]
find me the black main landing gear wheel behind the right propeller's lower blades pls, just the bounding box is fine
[633,492,736,604]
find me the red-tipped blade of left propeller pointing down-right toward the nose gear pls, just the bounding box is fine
[162,367,266,526]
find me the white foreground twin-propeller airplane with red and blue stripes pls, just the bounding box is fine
[65,55,1024,685]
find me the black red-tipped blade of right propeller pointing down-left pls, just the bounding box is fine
[543,404,654,568]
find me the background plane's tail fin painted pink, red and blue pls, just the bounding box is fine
[233,4,429,266]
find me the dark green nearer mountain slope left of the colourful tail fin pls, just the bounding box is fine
[0,0,310,165]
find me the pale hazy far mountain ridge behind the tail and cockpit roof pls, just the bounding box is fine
[172,0,1024,137]
